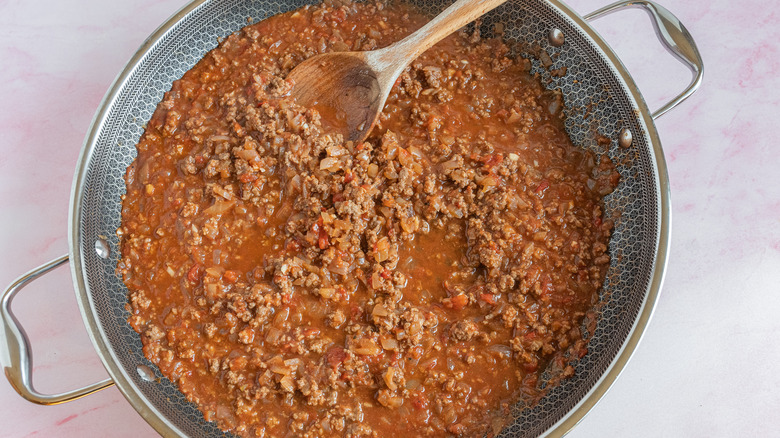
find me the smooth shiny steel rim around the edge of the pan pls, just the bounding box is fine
[68,0,671,437]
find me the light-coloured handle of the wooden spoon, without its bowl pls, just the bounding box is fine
[377,0,506,71]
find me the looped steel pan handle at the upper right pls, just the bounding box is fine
[584,0,704,119]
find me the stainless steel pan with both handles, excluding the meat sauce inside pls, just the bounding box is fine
[0,0,703,437]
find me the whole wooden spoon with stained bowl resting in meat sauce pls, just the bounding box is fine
[287,0,506,142]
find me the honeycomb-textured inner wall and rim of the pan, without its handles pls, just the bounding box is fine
[73,0,660,437]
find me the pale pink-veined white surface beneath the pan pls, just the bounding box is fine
[0,0,780,438]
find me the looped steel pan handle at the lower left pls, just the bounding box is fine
[0,255,114,405]
